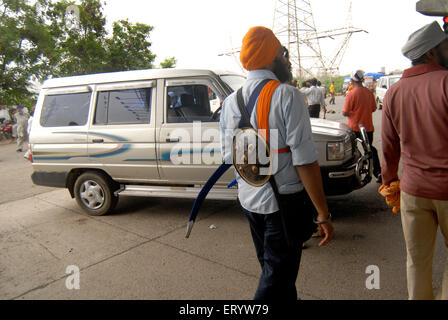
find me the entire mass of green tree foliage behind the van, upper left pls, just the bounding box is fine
[0,0,172,107]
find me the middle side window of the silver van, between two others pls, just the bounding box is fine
[94,88,152,125]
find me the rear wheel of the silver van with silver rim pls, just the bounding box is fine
[74,172,118,216]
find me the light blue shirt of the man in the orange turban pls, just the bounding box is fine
[220,69,318,214]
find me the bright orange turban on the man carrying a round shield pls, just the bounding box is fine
[240,27,281,71]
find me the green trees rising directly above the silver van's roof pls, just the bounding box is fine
[48,0,156,76]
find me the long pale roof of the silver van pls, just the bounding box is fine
[42,68,242,89]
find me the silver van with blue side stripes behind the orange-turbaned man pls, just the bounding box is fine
[30,69,371,215]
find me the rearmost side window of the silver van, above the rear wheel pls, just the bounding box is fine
[40,92,91,127]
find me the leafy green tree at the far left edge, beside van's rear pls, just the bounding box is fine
[0,0,54,105]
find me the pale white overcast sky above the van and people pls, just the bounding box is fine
[98,0,442,74]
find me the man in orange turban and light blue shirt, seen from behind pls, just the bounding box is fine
[220,27,333,300]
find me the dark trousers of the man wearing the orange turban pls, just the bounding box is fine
[243,191,316,300]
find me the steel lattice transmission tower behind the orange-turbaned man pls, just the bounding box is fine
[272,0,367,80]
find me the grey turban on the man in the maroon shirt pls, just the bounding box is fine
[401,21,447,61]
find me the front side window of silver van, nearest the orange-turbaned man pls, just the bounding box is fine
[166,85,219,123]
